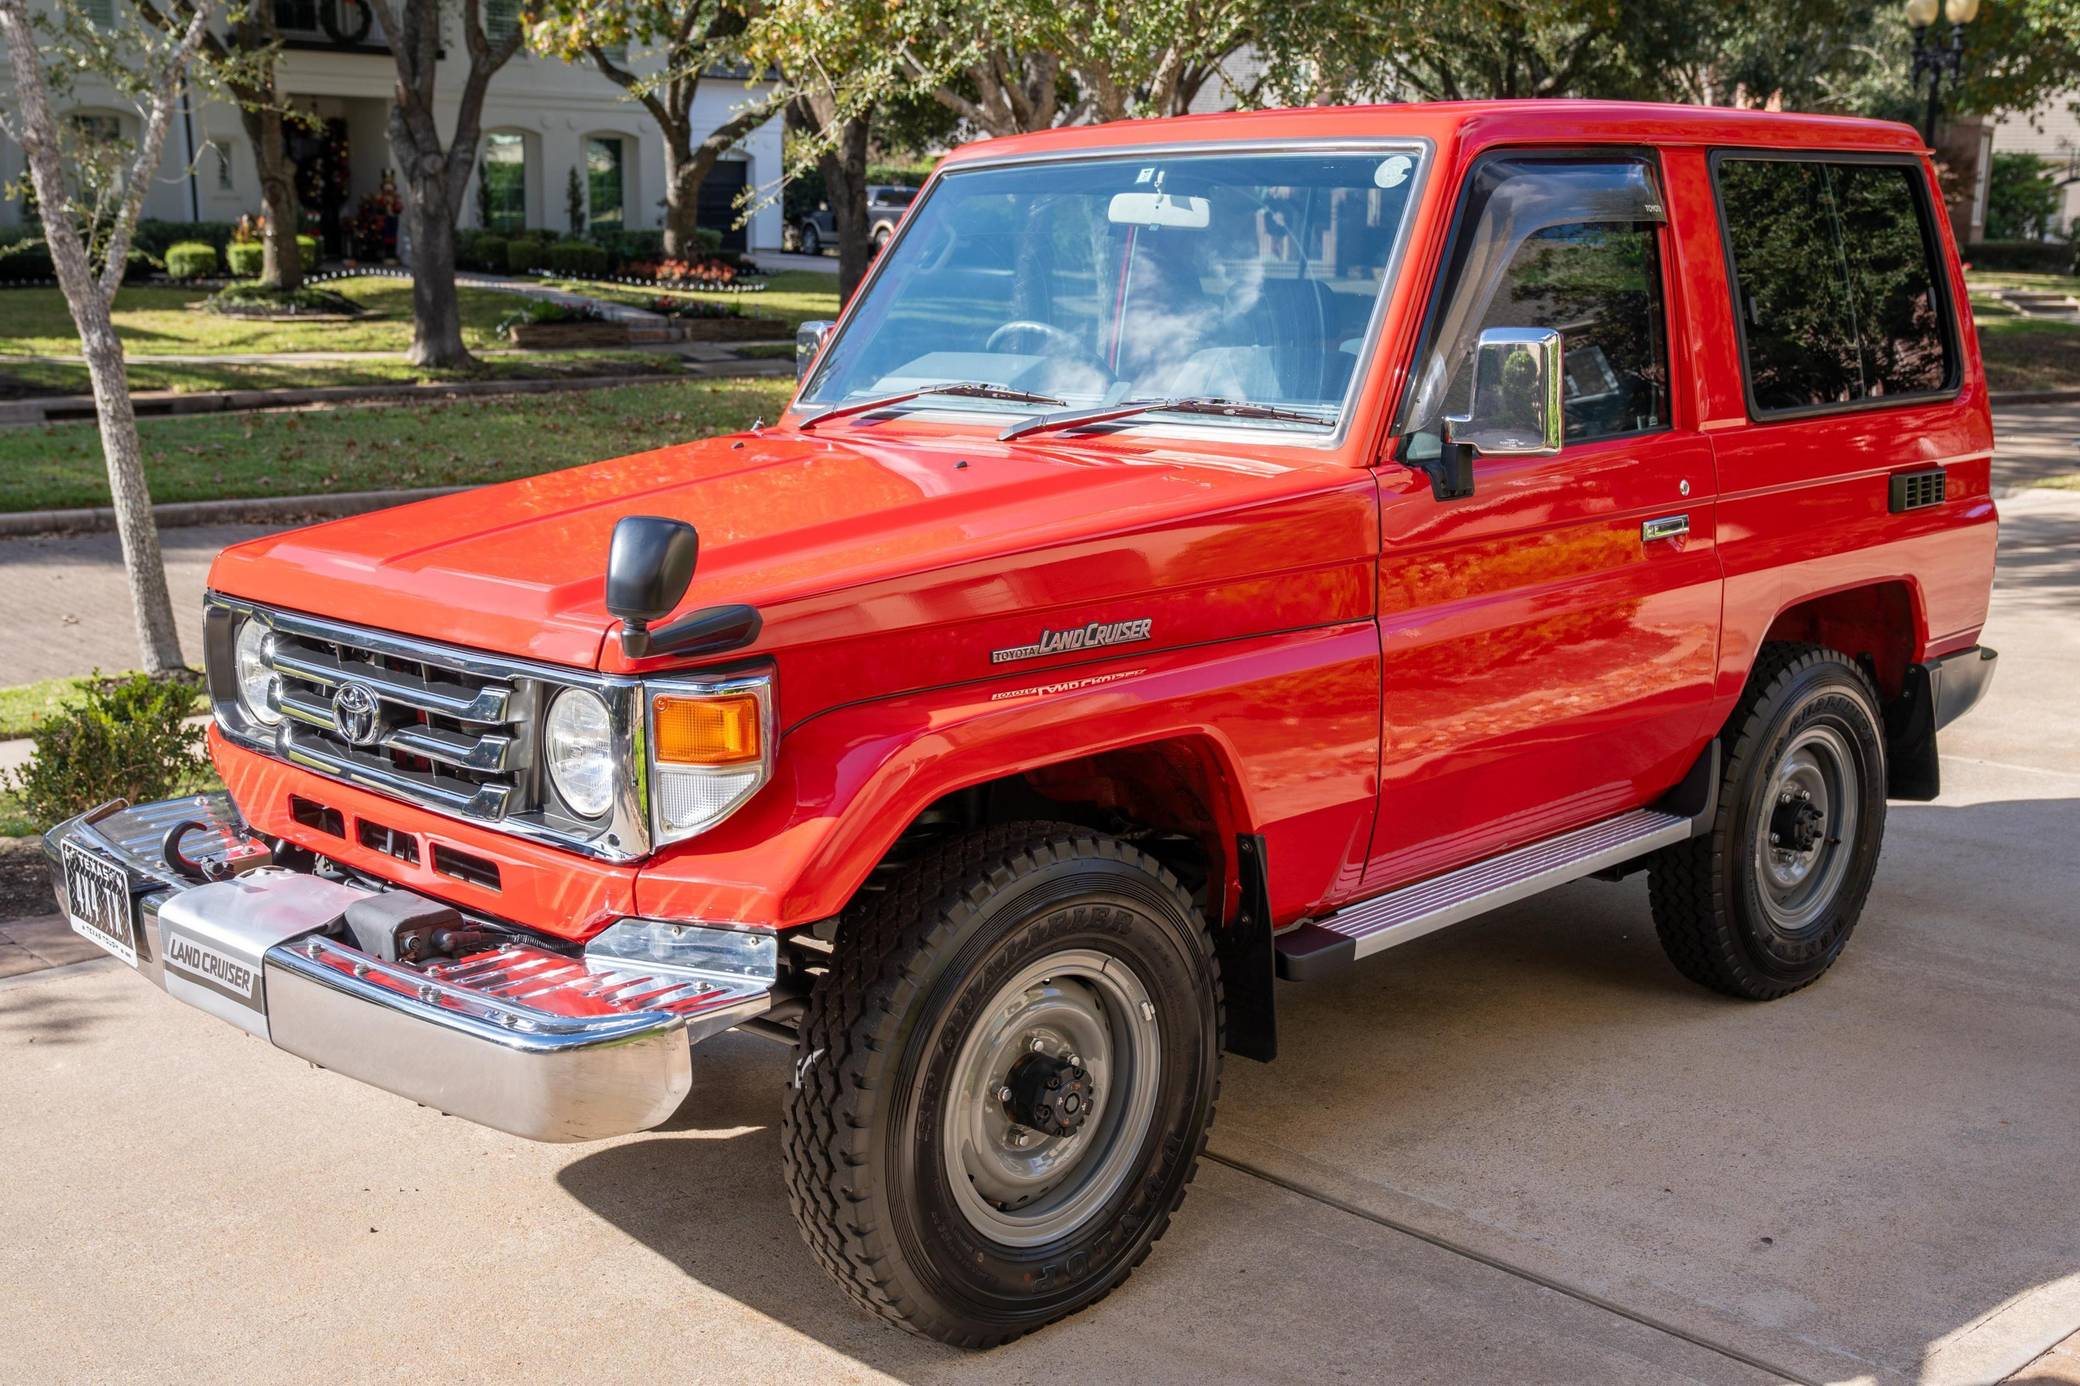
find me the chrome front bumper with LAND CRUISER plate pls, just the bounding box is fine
[44,795,778,1140]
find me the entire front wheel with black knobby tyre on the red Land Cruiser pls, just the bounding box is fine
[782,824,1221,1346]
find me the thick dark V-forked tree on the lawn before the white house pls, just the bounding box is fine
[366,0,520,368]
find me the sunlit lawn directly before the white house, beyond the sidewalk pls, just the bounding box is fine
[0,277,522,358]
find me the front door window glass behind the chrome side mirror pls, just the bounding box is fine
[1446,221,1668,443]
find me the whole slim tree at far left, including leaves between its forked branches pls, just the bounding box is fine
[0,0,214,674]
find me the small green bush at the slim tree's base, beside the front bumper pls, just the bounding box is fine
[10,674,204,826]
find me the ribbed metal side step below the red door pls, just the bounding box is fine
[1273,803,1718,982]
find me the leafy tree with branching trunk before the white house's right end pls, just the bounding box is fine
[528,0,784,258]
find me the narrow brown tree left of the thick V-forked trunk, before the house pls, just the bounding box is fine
[137,0,304,293]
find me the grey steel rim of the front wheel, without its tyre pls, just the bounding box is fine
[940,949,1163,1247]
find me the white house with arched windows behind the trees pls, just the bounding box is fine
[0,0,782,254]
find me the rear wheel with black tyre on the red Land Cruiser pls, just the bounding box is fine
[1647,643,1884,1001]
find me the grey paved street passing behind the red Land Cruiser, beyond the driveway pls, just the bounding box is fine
[0,402,2080,685]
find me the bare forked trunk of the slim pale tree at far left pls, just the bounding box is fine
[0,0,208,674]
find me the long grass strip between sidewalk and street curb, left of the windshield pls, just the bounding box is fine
[0,379,795,510]
